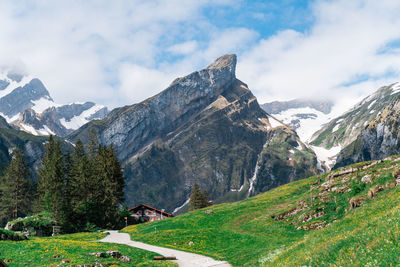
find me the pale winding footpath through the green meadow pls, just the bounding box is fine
[99,231,232,267]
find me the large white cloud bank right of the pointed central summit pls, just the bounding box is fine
[238,0,400,107]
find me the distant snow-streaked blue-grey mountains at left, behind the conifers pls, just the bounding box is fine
[0,70,108,136]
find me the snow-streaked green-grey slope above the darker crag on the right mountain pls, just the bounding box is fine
[311,83,400,167]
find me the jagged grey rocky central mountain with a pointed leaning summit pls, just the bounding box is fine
[69,55,317,212]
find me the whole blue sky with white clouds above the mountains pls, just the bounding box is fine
[0,0,400,111]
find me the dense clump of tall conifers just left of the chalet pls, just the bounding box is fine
[38,136,125,232]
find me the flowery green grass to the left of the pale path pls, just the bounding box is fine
[0,233,176,267]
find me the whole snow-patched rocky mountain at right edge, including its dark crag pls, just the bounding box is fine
[310,83,400,170]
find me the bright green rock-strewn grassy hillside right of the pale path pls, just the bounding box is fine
[125,157,400,266]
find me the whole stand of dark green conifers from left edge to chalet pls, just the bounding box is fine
[0,134,125,232]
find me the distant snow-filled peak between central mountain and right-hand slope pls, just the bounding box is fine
[261,99,333,142]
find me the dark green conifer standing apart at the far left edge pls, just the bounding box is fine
[0,148,32,219]
